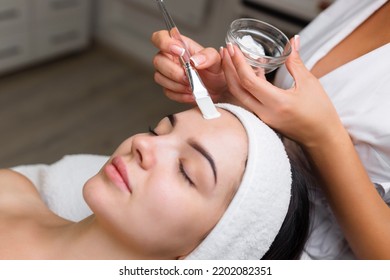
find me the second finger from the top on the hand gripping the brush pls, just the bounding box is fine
[153,52,189,86]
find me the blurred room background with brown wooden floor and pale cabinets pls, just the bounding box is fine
[0,0,333,168]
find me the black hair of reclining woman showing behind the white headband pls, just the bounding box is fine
[262,162,310,260]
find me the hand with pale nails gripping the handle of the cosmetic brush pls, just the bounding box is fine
[151,30,227,103]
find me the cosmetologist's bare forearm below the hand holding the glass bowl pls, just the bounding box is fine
[305,129,390,259]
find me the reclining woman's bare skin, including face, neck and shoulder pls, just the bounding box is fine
[0,109,247,260]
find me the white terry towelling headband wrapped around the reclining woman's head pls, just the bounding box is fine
[186,104,292,260]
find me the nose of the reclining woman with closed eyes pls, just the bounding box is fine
[132,134,156,170]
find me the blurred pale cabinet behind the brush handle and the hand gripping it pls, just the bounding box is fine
[96,0,240,64]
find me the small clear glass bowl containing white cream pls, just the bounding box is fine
[226,18,291,74]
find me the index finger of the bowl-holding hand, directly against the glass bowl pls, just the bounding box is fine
[228,45,279,104]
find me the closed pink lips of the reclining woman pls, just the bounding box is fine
[104,156,132,193]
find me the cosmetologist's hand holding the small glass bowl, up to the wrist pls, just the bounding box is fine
[222,38,345,148]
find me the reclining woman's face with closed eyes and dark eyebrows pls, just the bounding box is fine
[84,106,248,258]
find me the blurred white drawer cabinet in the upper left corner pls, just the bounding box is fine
[0,0,91,73]
